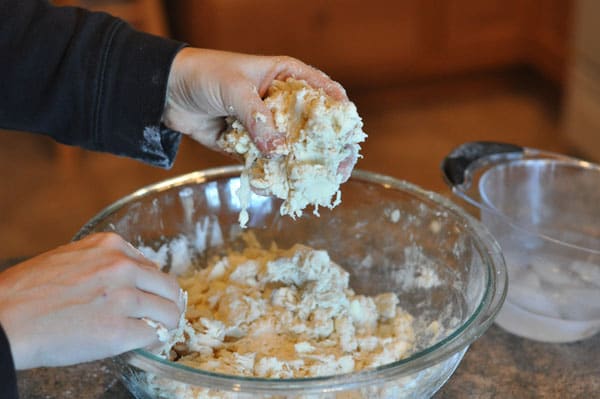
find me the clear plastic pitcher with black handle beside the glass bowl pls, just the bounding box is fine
[442,142,600,342]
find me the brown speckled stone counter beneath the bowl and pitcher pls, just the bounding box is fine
[18,326,600,399]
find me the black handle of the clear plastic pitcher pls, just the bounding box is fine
[441,141,524,187]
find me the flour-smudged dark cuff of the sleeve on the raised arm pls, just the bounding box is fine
[92,23,185,168]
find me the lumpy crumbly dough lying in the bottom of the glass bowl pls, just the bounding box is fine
[155,236,415,383]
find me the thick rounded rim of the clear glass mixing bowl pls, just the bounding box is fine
[73,165,508,393]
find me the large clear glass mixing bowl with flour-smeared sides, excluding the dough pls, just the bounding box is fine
[75,166,507,399]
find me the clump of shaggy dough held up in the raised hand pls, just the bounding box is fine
[219,78,367,227]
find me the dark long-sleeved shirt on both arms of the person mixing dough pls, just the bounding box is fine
[0,0,182,399]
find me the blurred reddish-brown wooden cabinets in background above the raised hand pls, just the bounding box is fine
[167,0,570,86]
